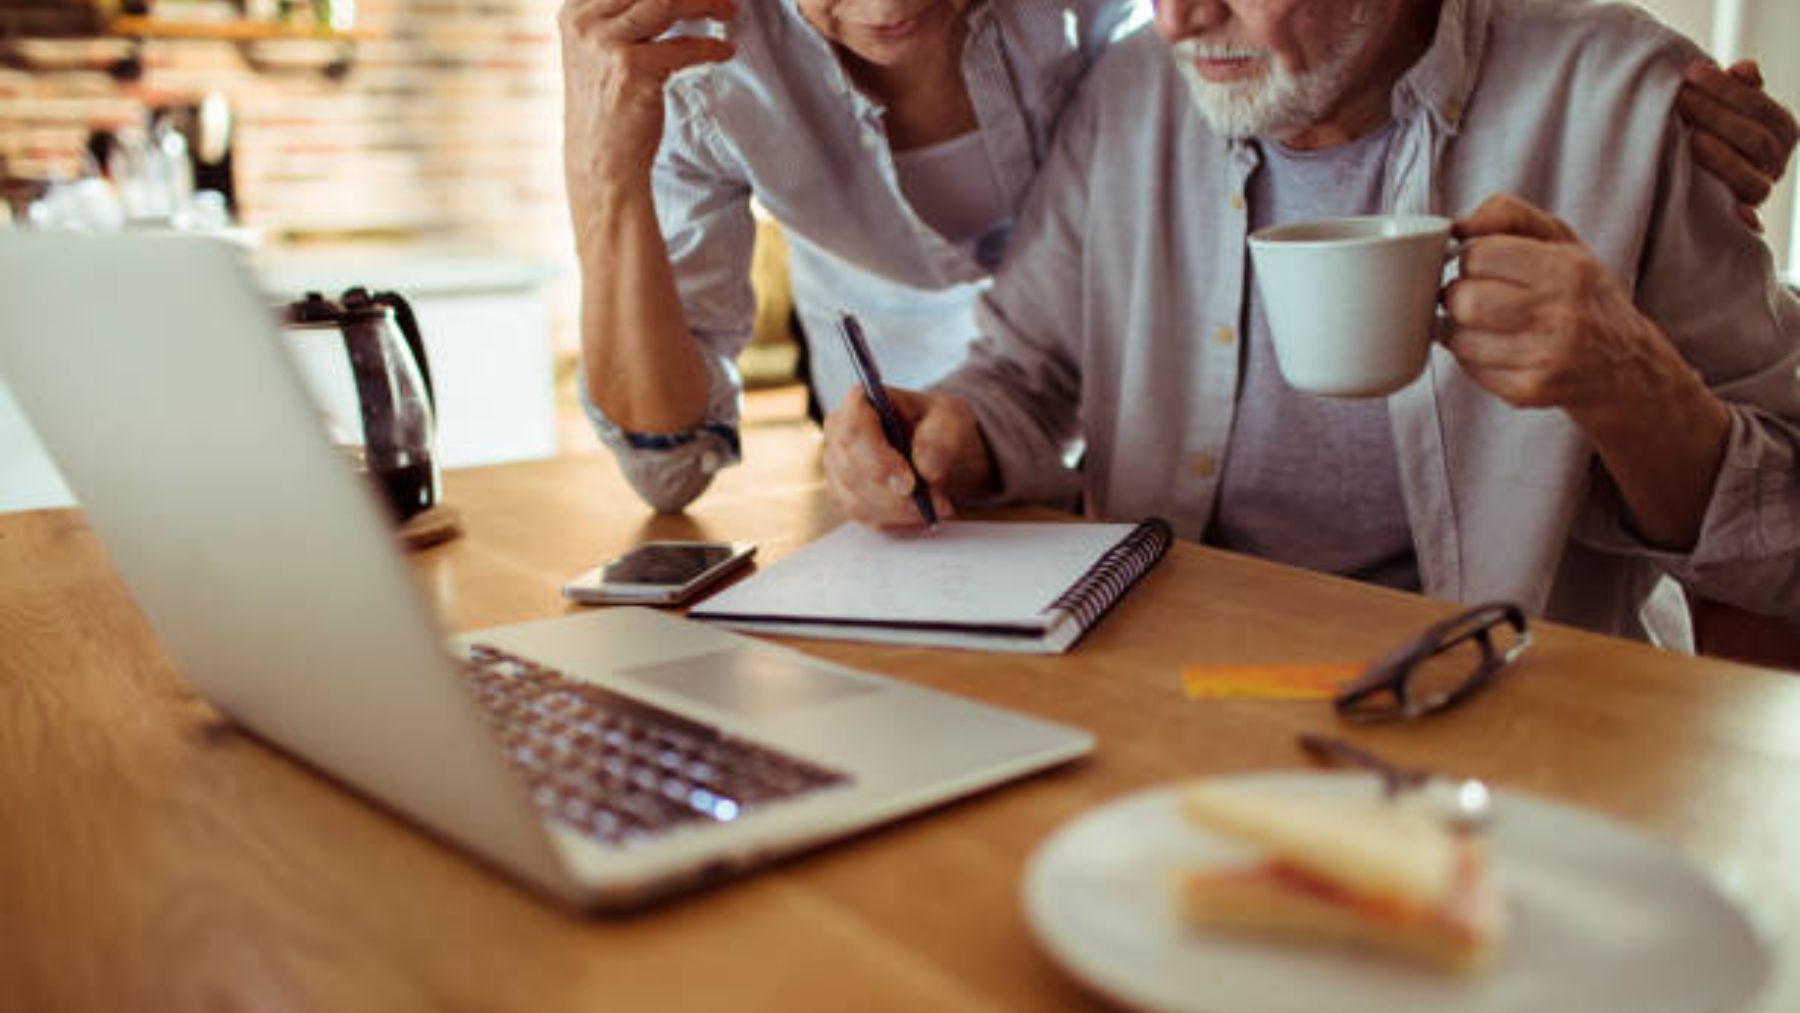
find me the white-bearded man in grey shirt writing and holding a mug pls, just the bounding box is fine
[826,0,1800,642]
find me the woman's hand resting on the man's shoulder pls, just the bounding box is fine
[1676,59,1800,232]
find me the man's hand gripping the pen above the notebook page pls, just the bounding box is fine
[824,387,994,527]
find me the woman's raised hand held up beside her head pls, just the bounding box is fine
[556,0,738,190]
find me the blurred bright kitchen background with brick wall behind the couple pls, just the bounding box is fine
[0,0,1800,509]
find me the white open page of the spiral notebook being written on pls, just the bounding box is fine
[695,520,1136,624]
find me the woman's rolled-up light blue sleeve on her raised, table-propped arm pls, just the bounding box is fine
[581,83,756,511]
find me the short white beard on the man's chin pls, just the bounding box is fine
[1172,0,1375,139]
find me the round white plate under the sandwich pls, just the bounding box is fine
[1024,774,1771,1013]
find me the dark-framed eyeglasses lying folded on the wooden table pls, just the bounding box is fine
[1336,601,1532,722]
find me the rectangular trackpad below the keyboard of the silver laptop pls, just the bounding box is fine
[616,648,880,718]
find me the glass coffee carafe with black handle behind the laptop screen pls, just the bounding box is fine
[284,288,441,522]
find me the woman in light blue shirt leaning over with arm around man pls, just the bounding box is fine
[562,0,1800,511]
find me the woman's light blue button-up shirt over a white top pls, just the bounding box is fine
[583,0,1148,509]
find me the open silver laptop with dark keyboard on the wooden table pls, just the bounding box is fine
[0,234,1093,909]
